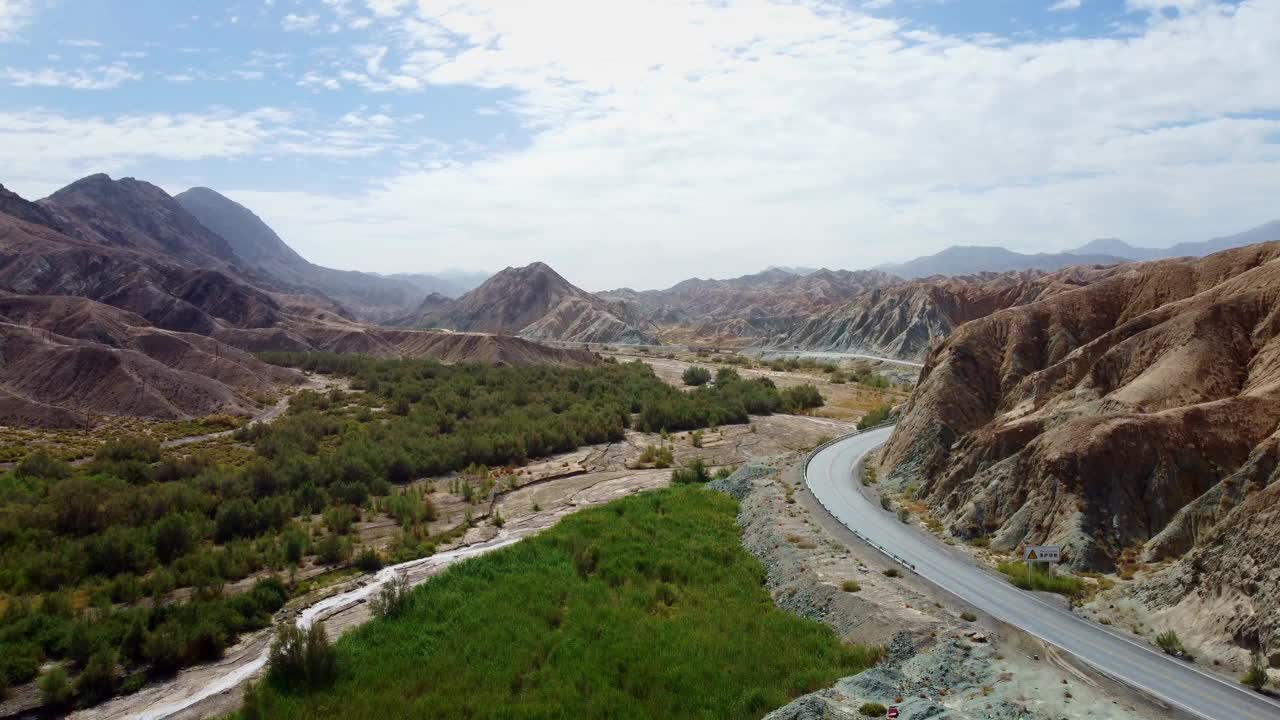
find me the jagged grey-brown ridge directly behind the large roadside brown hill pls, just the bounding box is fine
[772,268,1101,360]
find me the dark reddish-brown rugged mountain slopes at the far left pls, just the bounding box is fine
[0,177,593,427]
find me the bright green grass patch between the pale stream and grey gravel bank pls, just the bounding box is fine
[238,487,883,720]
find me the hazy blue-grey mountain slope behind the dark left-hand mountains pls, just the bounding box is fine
[174,187,478,320]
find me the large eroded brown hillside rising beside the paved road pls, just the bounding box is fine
[878,242,1280,647]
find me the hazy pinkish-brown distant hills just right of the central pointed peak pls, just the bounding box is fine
[600,268,901,345]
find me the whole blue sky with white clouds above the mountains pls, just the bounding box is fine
[0,0,1280,290]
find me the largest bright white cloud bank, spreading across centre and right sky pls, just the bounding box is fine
[215,0,1280,288]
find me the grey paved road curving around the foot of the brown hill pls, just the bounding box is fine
[805,428,1280,720]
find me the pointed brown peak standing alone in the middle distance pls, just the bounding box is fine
[414,263,655,343]
